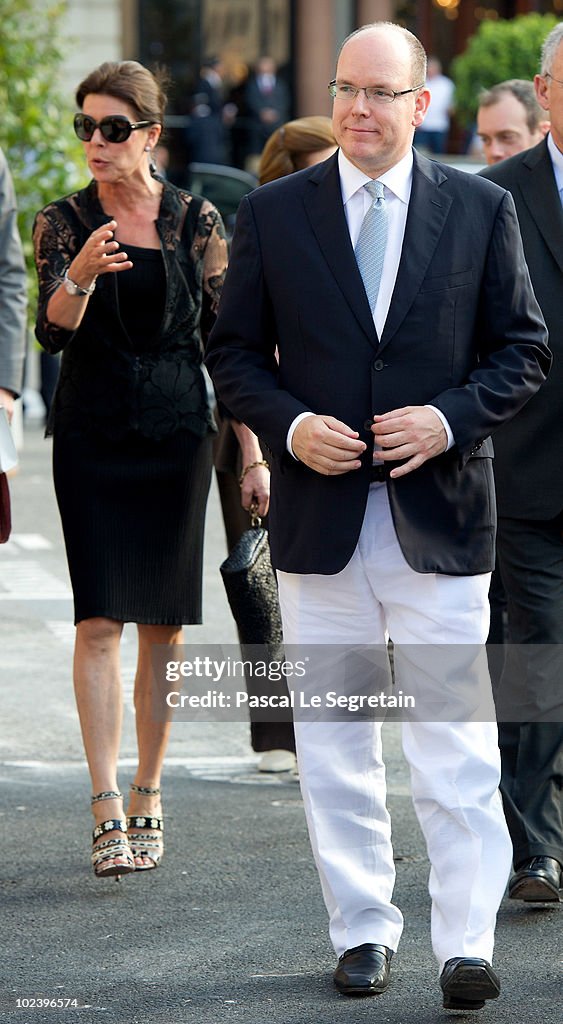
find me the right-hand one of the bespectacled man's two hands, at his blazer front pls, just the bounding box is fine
[372,406,447,479]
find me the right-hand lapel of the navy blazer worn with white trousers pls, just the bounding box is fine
[380,151,451,347]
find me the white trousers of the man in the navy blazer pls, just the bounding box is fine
[278,484,512,970]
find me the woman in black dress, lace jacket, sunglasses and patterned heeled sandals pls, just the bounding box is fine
[34,60,227,877]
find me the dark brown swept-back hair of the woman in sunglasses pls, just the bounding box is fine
[76,60,168,124]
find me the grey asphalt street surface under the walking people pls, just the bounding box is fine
[0,424,563,1024]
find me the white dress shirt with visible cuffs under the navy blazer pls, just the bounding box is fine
[287,150,453,458]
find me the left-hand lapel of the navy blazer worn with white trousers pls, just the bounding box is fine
[305,155,378,348]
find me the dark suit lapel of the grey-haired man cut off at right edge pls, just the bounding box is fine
[519,140,563,270]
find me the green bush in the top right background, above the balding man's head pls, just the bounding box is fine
[451,14,558,126]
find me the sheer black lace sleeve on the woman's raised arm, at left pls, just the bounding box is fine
[33,206,77,353]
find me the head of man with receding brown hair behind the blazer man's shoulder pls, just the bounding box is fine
[477,78,550,167]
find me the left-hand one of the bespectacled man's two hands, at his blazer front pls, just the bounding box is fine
[292,416,366,476]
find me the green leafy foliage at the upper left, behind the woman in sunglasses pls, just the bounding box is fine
[0,0,87,310]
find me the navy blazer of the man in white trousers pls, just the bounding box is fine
[207,152,551,575]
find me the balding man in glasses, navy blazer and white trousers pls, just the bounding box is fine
[207,23,550,1010]
